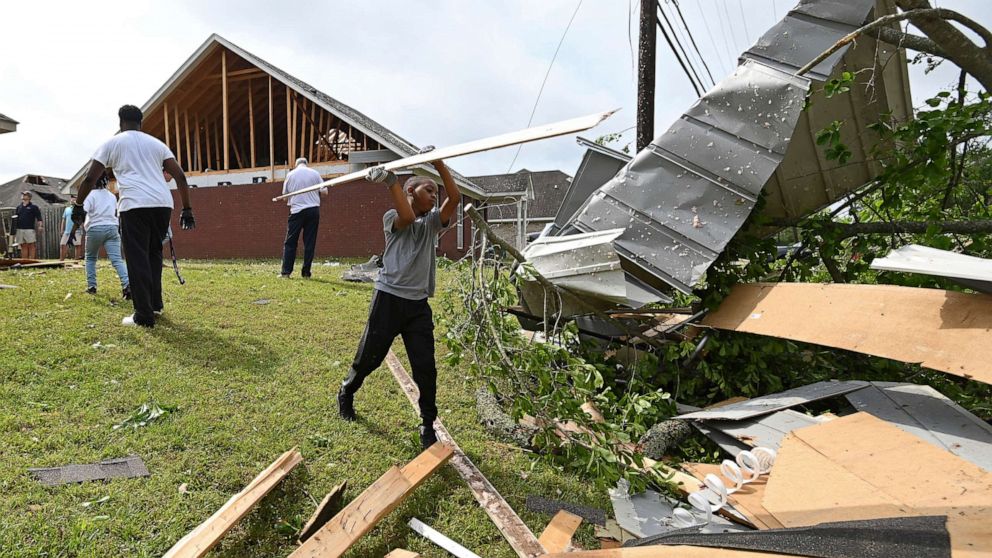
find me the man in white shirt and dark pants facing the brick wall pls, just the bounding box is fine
[279,157,327,279]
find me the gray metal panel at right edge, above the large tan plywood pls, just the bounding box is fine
[845,382,992,471]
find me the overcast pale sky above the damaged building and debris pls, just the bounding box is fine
[0,0,992,183]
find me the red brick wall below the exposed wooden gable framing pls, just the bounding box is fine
[172,181,471,259]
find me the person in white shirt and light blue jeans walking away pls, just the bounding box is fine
[83,175,131,300]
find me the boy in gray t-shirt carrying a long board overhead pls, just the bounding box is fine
[338,161,461,449]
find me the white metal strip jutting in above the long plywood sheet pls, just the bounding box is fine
[871,244,992,294]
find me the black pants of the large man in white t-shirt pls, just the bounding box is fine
[121,207,172,326]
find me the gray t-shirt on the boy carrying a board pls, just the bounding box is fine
[375,208,444,300]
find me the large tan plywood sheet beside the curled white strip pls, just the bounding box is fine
[763,413,992,556]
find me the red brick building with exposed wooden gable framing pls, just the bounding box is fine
[65,34,486,258]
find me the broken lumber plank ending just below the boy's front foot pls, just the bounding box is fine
[290,442,453,558]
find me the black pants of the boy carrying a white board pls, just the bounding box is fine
[341,289,437,426]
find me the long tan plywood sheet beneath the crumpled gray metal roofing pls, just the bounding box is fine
[702,283,992,383]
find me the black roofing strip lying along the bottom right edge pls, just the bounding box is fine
[625,516,951,558]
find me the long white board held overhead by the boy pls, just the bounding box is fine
[272,109,620,201]
